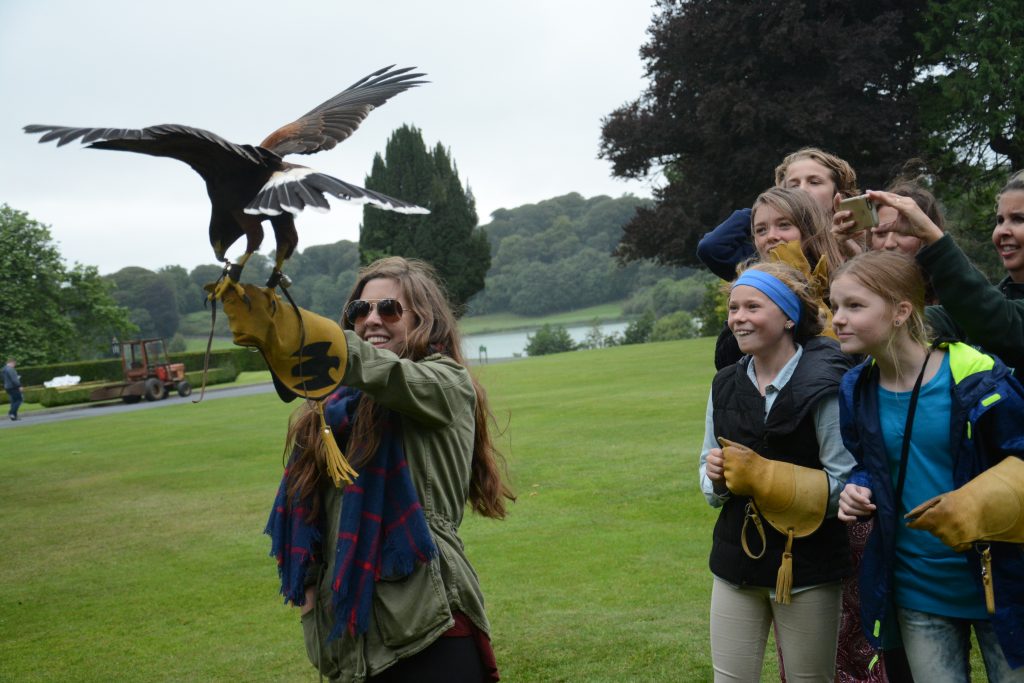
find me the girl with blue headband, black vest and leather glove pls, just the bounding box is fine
[699,263,854,681]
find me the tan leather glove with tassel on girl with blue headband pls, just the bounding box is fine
[718,436,828,604]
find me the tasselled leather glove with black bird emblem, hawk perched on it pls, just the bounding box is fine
[214,284,356,486]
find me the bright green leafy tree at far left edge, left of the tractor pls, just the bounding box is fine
[0,204,134,366]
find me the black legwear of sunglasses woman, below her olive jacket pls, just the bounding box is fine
[367,637,483,683]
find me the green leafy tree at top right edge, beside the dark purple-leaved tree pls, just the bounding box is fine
[913,0,1024,280]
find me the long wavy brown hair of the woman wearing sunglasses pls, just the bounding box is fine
[285,256,515,521]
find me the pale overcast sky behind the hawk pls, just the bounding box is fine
[0,0,653,273]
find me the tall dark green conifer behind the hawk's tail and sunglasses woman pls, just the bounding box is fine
[359,126,490,310]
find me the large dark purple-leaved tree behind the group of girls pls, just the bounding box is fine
[600,0,925,264]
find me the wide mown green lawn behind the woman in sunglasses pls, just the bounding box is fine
[0,339,987,683]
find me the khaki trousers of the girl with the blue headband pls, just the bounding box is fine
[711,578,843,683]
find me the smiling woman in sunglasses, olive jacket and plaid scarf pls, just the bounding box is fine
[268,257,514,683]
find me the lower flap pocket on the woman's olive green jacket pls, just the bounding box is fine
[374,559,452,648]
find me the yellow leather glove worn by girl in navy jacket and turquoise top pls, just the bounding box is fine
[906,456,1024,552]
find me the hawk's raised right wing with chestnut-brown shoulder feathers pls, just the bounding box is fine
[260,65,427,157]
